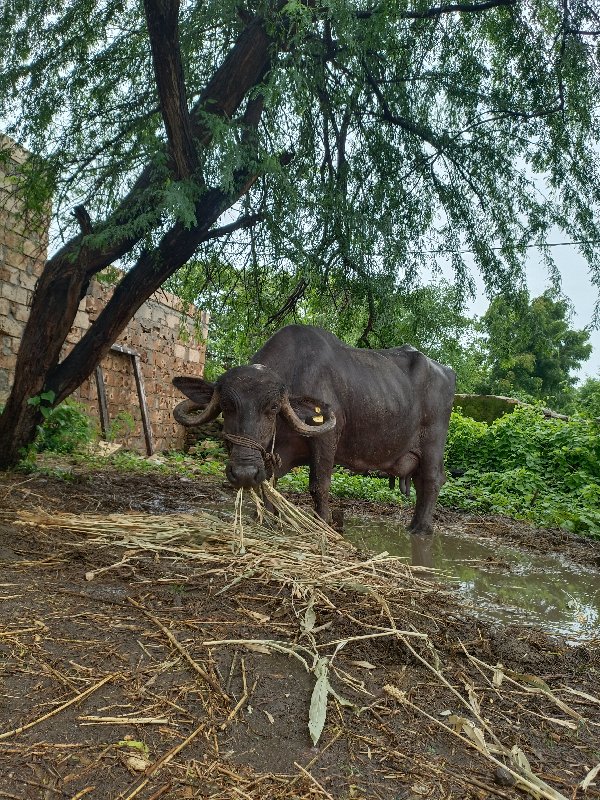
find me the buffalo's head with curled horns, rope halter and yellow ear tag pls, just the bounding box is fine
[173,364,335,488]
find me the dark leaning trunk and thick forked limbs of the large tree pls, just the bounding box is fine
[0,7,272,469]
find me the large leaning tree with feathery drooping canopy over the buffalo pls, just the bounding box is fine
[0,0,600,463]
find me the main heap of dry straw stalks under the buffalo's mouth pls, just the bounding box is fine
[4,484,440,597]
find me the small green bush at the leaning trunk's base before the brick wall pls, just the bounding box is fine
[30,392,97,454]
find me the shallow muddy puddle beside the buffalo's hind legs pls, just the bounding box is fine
[344,517,600,642]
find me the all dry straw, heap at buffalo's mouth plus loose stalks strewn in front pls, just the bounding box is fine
[0,486,600,800]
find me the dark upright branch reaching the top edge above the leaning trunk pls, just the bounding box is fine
[144,0,198,179]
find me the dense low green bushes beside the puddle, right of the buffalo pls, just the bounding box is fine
[440,407,600,535]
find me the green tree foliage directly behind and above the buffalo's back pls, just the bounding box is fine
[167,261,487,392]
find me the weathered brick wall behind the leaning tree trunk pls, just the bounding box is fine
[0,139,208,452]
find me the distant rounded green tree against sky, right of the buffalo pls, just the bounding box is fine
[479,290,592,408]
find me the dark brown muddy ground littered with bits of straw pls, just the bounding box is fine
[0,469,600,800]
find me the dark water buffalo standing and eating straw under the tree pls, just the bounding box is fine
[173,325,455,533]
